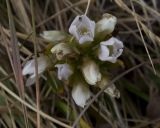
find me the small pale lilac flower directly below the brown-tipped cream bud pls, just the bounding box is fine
[55,64,73,80]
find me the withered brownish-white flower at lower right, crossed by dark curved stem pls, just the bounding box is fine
[98,77,120,98]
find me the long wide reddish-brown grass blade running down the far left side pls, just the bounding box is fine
[6,0,28,128]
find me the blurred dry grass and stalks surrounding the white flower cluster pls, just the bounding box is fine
[0,0,160,128]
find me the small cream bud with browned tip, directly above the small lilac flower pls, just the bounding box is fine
[51,43,73,60]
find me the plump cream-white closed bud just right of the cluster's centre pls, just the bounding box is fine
[81,60,101,85]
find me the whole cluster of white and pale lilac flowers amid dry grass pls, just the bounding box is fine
[23,14,124,107]
